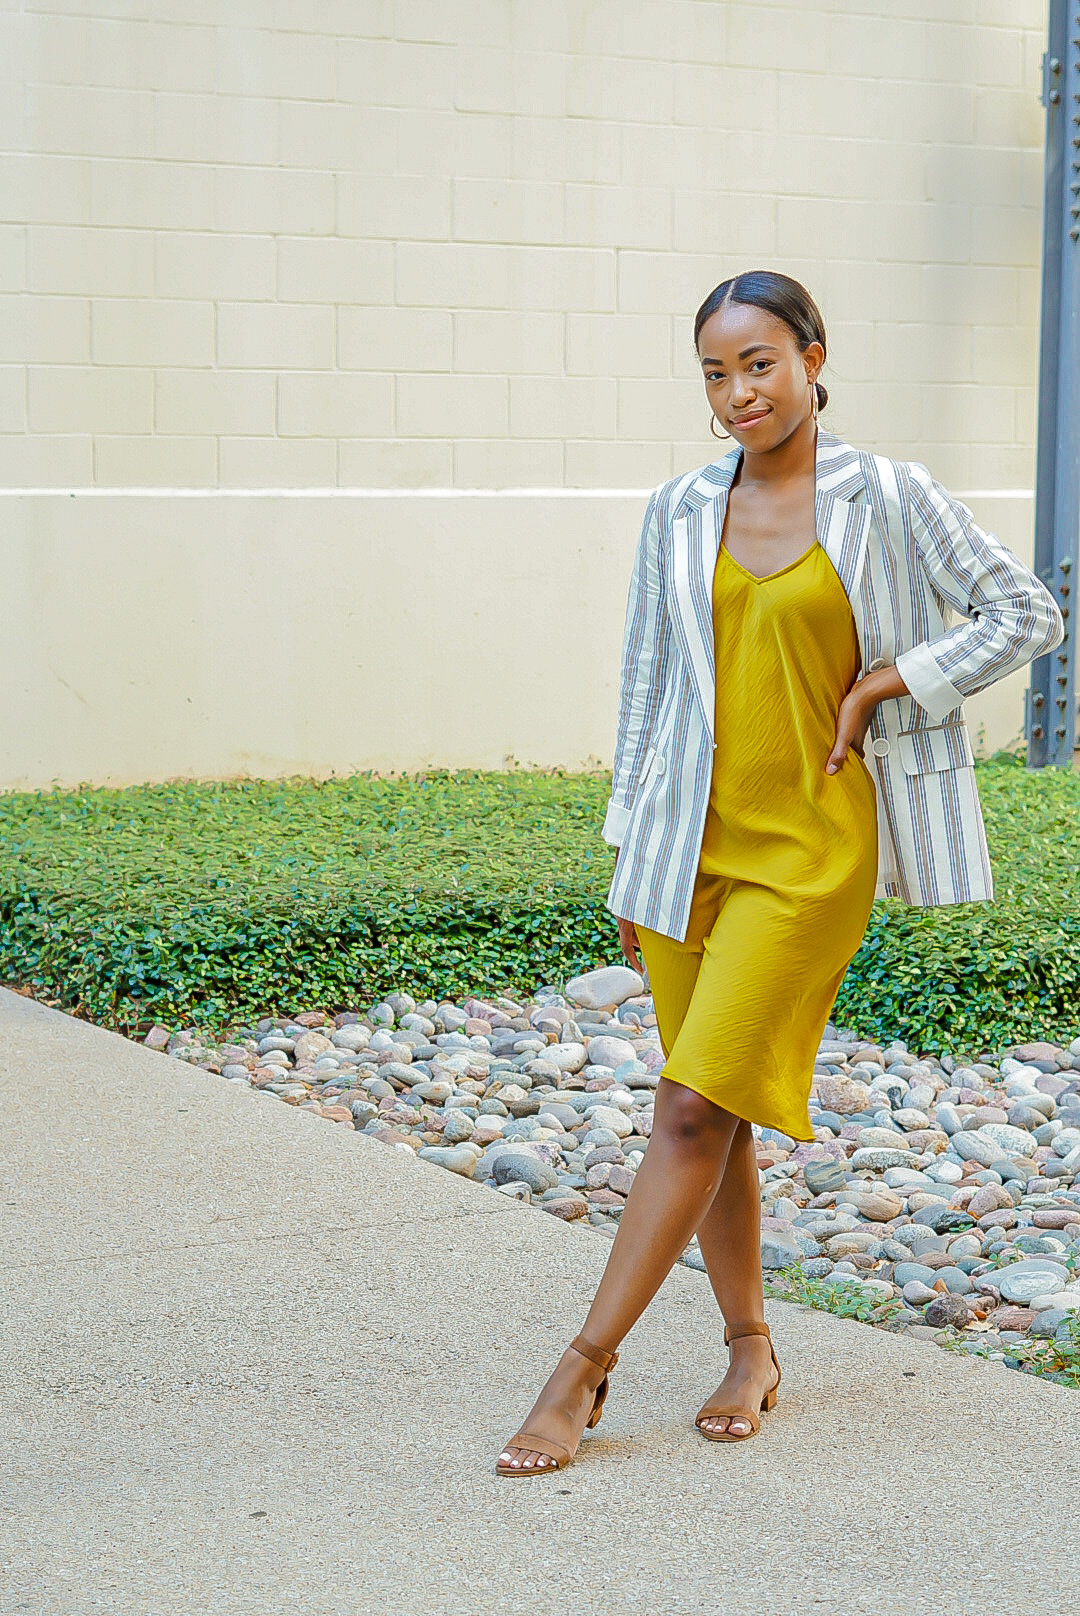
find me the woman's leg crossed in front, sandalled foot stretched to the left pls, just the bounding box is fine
[500,1078,743,1469]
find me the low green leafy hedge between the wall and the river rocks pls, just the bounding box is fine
[0,755,1080,1052]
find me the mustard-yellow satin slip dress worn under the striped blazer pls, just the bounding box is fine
[637,541,878,1139]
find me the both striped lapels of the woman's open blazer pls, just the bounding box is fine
[668,428,871,740]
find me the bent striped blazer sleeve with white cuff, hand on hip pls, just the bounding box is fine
[896,462,1065,721]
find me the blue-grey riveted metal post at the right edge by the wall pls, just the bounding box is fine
[1025,0,1080,769]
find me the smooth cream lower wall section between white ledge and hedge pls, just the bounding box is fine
[0,490,1031,789]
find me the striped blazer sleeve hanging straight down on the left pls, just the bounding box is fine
[600,485,671,847]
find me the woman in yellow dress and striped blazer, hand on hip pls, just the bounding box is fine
[496,271,1064,1475]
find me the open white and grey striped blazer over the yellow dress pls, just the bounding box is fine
[601,428,1064,941]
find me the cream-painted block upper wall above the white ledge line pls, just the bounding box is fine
[0,0,1046,491]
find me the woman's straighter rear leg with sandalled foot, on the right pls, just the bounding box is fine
[695,1120,776,1435]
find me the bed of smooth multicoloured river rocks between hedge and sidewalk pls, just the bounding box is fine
[146,966,1080,1383]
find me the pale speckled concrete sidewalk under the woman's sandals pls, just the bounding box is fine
[0,992,1080,1616]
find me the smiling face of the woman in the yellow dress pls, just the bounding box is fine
[697,304,825,454]
